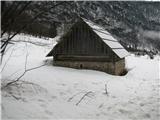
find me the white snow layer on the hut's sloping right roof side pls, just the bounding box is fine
[82,18,129,58]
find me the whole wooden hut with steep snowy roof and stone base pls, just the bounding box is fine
[47,18,128,75]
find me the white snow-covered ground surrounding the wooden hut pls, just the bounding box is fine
[1,35,160,120]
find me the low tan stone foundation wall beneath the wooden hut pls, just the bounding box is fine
[53,60,125,75]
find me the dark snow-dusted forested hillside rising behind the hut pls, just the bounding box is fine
[2,1,160,51]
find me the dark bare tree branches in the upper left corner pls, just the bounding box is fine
[1,1,66,62]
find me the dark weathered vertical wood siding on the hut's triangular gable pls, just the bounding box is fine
[53,21,119,61]
